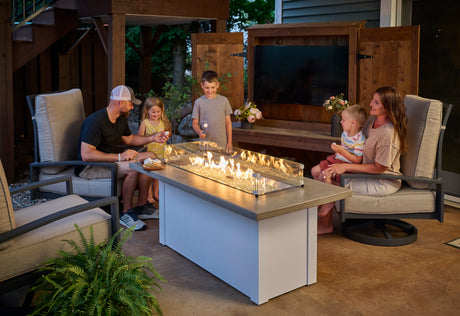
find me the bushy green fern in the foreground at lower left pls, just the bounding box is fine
[31,225,166,315]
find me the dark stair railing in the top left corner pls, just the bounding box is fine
[11,0,57,32]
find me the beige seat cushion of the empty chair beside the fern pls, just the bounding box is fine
[0,195,111,282]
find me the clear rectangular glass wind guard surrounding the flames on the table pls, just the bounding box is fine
[165,141,304,196]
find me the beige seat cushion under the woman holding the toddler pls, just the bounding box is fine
[345,185,436,214]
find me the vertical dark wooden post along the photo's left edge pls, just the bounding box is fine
[0,0,15,183]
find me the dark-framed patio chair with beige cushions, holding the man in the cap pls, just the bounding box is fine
[26,89,121,199]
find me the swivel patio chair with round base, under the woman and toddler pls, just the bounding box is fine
[340,95,452,246]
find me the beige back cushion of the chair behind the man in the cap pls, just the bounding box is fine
[35,89,85,174]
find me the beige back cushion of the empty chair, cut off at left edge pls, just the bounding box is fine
[0,160,16,251]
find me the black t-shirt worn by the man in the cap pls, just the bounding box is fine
[75,108,131,175]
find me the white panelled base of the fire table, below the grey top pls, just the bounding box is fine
[159,181,317,305]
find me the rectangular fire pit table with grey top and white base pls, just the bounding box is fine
[130,162,351,305]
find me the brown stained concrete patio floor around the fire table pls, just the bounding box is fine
[124,206,460,316]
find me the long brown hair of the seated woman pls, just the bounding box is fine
[375,87,407,154]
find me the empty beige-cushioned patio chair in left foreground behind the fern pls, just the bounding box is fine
[0,161,119,294]
